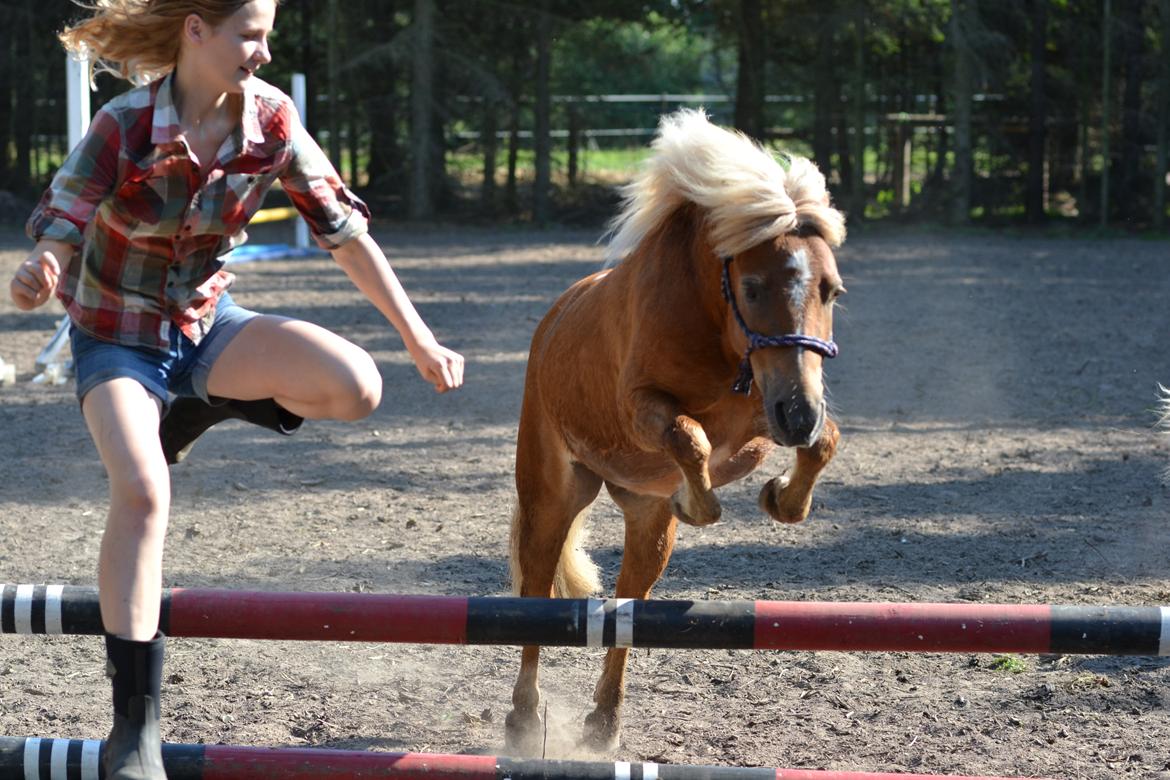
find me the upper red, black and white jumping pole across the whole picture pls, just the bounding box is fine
[0,585,1170,656]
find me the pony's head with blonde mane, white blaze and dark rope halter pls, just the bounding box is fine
[606,109,845,447]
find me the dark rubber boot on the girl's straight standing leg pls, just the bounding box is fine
[102,634,166,780]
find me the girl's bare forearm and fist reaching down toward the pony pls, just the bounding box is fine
[332,234,463,393]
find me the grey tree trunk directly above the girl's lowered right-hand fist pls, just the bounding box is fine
[411,0,435,220]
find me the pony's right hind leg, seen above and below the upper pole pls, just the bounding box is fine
[585,484,679,751]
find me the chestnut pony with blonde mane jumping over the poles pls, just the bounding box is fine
[507,110,845,754]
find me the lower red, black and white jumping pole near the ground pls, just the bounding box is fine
[0,737,1062,780]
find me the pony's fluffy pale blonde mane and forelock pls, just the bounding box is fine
[606,109,845,263]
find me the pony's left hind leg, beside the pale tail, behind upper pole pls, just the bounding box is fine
[504,447,601,755]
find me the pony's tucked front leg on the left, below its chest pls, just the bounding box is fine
[633,389,723,525]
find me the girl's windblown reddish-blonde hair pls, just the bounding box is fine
[59,0,269,84]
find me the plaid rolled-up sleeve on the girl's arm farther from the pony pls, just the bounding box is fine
[25,109,122,246]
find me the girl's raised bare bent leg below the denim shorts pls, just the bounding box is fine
[207,316,381,420]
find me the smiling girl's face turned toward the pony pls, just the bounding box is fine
[183,0,276,94]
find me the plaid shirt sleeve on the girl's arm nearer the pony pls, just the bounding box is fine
[281,111,370,250]
